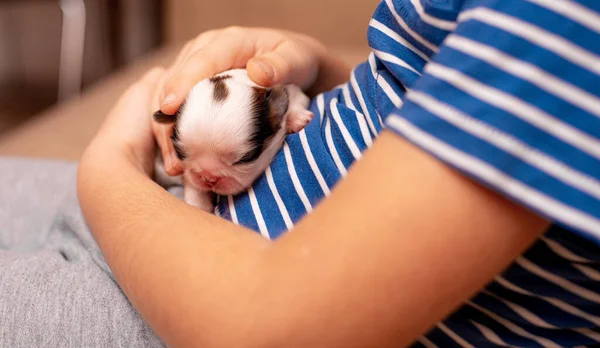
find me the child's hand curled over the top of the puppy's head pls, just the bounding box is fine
[153,27,350,175]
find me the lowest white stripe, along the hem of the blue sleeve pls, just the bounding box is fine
[387,114,600,239]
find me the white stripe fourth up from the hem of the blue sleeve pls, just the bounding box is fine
[445,35,600,117]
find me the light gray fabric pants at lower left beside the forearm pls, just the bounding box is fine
[0,158,164,348]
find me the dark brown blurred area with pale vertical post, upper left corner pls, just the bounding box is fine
[0,0,164,133]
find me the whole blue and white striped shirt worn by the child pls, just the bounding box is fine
[216,0,600,347]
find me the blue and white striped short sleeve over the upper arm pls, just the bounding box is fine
[386,0,600,242]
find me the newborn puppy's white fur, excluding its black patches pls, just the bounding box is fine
[157,69,313,211]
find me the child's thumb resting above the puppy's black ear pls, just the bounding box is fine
[246,40,319,89]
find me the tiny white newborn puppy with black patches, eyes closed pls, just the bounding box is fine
[154,69,313,212]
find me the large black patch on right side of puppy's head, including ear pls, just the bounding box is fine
[235,86,289,164]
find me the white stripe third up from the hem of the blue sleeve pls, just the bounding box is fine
[425,63,600,159]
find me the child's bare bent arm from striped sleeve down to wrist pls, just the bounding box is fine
[79,119,548,347]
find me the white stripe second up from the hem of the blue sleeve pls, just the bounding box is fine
[406,91,600,200]
